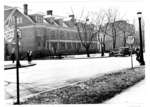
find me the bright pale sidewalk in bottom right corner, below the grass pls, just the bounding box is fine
[104,80,145,105]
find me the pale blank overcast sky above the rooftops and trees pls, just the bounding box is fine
[4,0,144,23]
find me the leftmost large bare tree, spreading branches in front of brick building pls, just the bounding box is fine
[71,8,97,57]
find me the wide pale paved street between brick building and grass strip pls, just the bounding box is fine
[5,54,139,102]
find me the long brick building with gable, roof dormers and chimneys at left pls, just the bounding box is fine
[4,4,97,59]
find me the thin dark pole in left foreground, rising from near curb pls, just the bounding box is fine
[14,16,20,104]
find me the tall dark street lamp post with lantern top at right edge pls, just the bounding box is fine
[137,12,145,65]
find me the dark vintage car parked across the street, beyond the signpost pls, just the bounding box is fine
[109,47,130,56]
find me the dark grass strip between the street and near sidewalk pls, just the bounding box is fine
[22,66,145,104]
